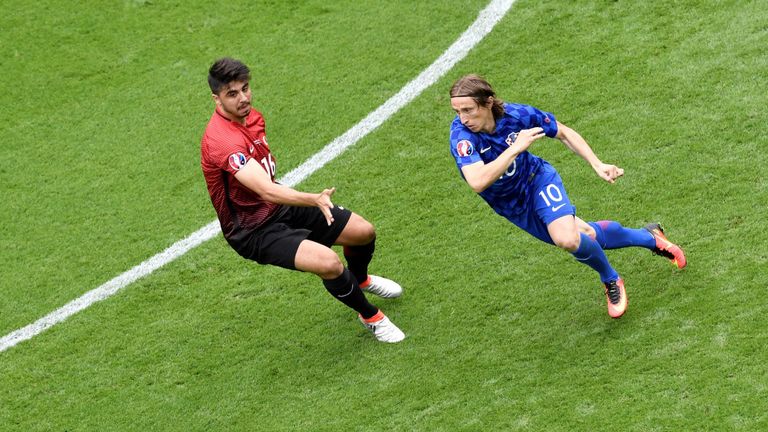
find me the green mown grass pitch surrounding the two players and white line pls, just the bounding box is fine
[0,0,768,432]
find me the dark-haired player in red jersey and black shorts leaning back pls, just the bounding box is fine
[200,58,405,342]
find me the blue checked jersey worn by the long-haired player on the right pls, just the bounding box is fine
[451,103,557,217]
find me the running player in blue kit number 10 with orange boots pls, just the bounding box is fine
[450,75,686,318]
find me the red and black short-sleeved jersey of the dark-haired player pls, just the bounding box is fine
[200,109,280,238]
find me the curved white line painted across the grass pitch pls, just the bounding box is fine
[0,0,516,352]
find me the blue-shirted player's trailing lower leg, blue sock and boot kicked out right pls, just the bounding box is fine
[582,220,687,268]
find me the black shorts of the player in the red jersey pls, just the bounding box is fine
[227,206,352,270]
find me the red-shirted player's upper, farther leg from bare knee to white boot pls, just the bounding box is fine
[335,213,403,298]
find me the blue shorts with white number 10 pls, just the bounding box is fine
[506,165,576,244]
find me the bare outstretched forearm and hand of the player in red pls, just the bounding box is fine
[235,159,336,225]
